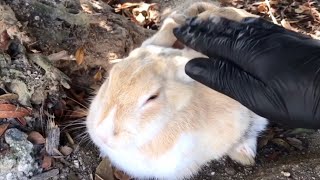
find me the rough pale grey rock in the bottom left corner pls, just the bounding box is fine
[0,128,39,180]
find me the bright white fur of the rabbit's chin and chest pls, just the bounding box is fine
[101,133,212,179]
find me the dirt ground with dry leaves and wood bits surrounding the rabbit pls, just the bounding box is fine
[0,0,320,180]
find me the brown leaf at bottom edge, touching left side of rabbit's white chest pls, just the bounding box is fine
[95,158,114,180]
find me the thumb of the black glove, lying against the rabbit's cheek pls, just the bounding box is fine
[185,58,287,124]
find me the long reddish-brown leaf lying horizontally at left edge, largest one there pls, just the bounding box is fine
[0,104,30,118]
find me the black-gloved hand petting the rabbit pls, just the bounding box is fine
[174,17,320,129]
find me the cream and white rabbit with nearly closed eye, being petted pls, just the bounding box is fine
[87,0,267,179]
